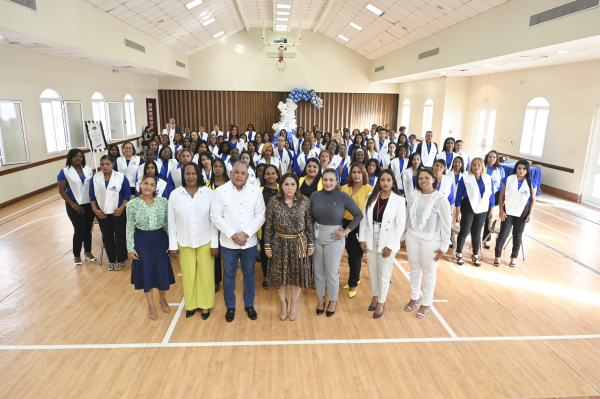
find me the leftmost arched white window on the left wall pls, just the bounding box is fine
[40,89,68,154]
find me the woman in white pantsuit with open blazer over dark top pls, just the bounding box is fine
[359,169,406,319]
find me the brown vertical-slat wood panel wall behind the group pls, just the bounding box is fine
[158,90,399,132]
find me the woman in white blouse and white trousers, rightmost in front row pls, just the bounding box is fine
[402,169,451,319]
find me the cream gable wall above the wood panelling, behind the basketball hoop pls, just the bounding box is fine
[159,29,398,93]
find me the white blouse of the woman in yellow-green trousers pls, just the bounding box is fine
[169,187,219,251]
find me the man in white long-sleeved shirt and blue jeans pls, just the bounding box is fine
[210,161,266,322]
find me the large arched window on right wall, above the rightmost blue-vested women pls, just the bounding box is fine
[519,97,550,157]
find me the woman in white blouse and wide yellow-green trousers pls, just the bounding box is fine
[169,162,219,320]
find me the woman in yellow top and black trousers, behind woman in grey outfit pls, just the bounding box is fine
[342,163,373,298]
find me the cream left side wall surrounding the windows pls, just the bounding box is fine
[0,46,158,204]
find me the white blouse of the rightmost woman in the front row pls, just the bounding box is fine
[402,190,452,256]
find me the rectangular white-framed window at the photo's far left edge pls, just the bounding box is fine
[0,100,29,165]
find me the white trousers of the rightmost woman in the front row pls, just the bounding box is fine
[405,232,442,306]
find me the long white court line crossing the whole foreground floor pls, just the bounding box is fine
[0,334,600,351]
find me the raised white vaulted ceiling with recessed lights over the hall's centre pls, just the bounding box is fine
[85,0,508,60]
